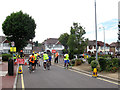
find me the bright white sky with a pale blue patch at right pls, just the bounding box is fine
[0,0,120,44]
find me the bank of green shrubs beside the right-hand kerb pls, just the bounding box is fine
[71,55,120,73]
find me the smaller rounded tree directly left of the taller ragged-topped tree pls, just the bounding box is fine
[59,33,69,52]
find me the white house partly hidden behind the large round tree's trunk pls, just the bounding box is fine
[0,36,32,54]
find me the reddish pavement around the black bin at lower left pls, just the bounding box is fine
[0,62,17,90]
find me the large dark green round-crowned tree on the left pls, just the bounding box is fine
[2,11,36,51]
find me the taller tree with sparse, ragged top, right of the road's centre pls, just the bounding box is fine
[67,23,88,56]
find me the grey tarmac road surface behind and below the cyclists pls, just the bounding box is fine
[17,61,118,88]
